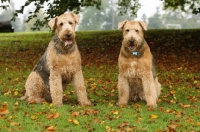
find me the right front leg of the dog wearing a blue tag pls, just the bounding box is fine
[142,72,157,108]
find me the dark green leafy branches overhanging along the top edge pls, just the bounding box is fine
[0,0,200,30]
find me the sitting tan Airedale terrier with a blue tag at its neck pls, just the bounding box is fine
[118,20,161,107]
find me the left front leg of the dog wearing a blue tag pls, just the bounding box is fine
[117,74,129,106]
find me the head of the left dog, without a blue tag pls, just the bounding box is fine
[48,12,80,46]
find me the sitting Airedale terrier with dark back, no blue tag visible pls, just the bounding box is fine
[21,12,91,106]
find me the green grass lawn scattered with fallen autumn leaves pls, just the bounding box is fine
[0,30,200,132]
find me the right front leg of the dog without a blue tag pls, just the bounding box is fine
[73,70,91,106]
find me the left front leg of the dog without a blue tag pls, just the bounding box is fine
[49,70,63,106]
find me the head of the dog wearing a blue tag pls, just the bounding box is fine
[118,20,147,51]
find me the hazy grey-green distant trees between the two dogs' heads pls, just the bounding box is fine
[78,0,133,30]
